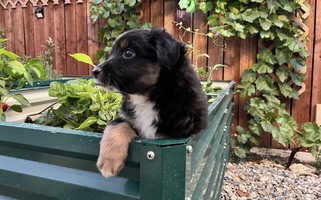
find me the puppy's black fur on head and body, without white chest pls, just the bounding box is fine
[93,29,208,138]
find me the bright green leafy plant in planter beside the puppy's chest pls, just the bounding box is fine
[35,79,121,132]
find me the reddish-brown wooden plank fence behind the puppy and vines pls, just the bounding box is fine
[0,0,321,147]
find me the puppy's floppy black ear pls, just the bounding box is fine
[149,29,185,68]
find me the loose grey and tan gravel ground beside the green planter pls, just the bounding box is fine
[221,154,321,200]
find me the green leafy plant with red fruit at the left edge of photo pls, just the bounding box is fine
[0,34,44,121]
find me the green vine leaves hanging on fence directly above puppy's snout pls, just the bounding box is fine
[89,0,151,62]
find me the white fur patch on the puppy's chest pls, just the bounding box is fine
[130,95,158,139]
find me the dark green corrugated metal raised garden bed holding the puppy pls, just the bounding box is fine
[0,82,234,200]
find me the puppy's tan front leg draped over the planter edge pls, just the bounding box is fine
[97,122,137,178]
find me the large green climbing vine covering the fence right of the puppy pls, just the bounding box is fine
[179,0,321,157]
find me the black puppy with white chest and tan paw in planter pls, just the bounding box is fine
[93,29,208,177]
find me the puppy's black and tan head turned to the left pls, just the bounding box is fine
[93,29,185,94]
